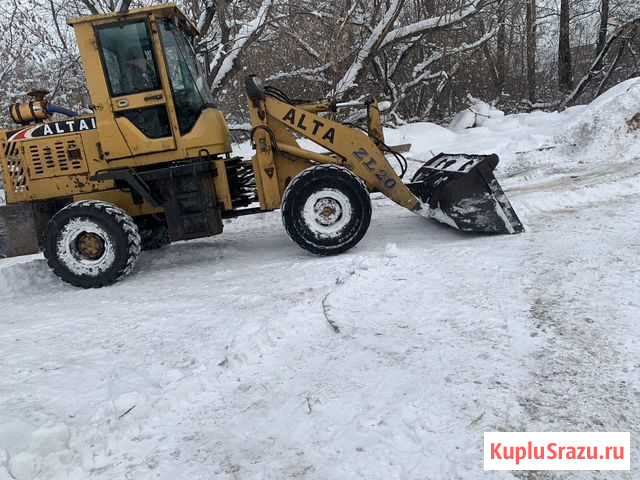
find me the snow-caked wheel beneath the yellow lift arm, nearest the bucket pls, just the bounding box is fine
[282,165,371,255]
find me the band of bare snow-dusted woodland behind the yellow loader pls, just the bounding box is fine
[0,0,640,131]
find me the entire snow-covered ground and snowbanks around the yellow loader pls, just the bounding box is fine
[0,80,640,480]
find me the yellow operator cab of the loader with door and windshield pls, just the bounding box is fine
[70,5,231,166]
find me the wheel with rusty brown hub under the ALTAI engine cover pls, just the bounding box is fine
[44,200,141,288]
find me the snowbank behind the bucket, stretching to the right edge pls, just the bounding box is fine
[385,79,640,222]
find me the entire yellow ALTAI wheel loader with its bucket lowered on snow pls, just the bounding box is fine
[0,5,523,287]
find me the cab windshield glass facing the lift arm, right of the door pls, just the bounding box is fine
[160,19,213,135]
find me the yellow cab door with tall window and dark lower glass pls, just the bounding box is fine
[95,19,176,161]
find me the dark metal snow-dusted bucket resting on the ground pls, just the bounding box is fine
[408,153,524,234]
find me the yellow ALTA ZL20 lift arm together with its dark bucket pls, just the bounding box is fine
[246,76,524,234]
